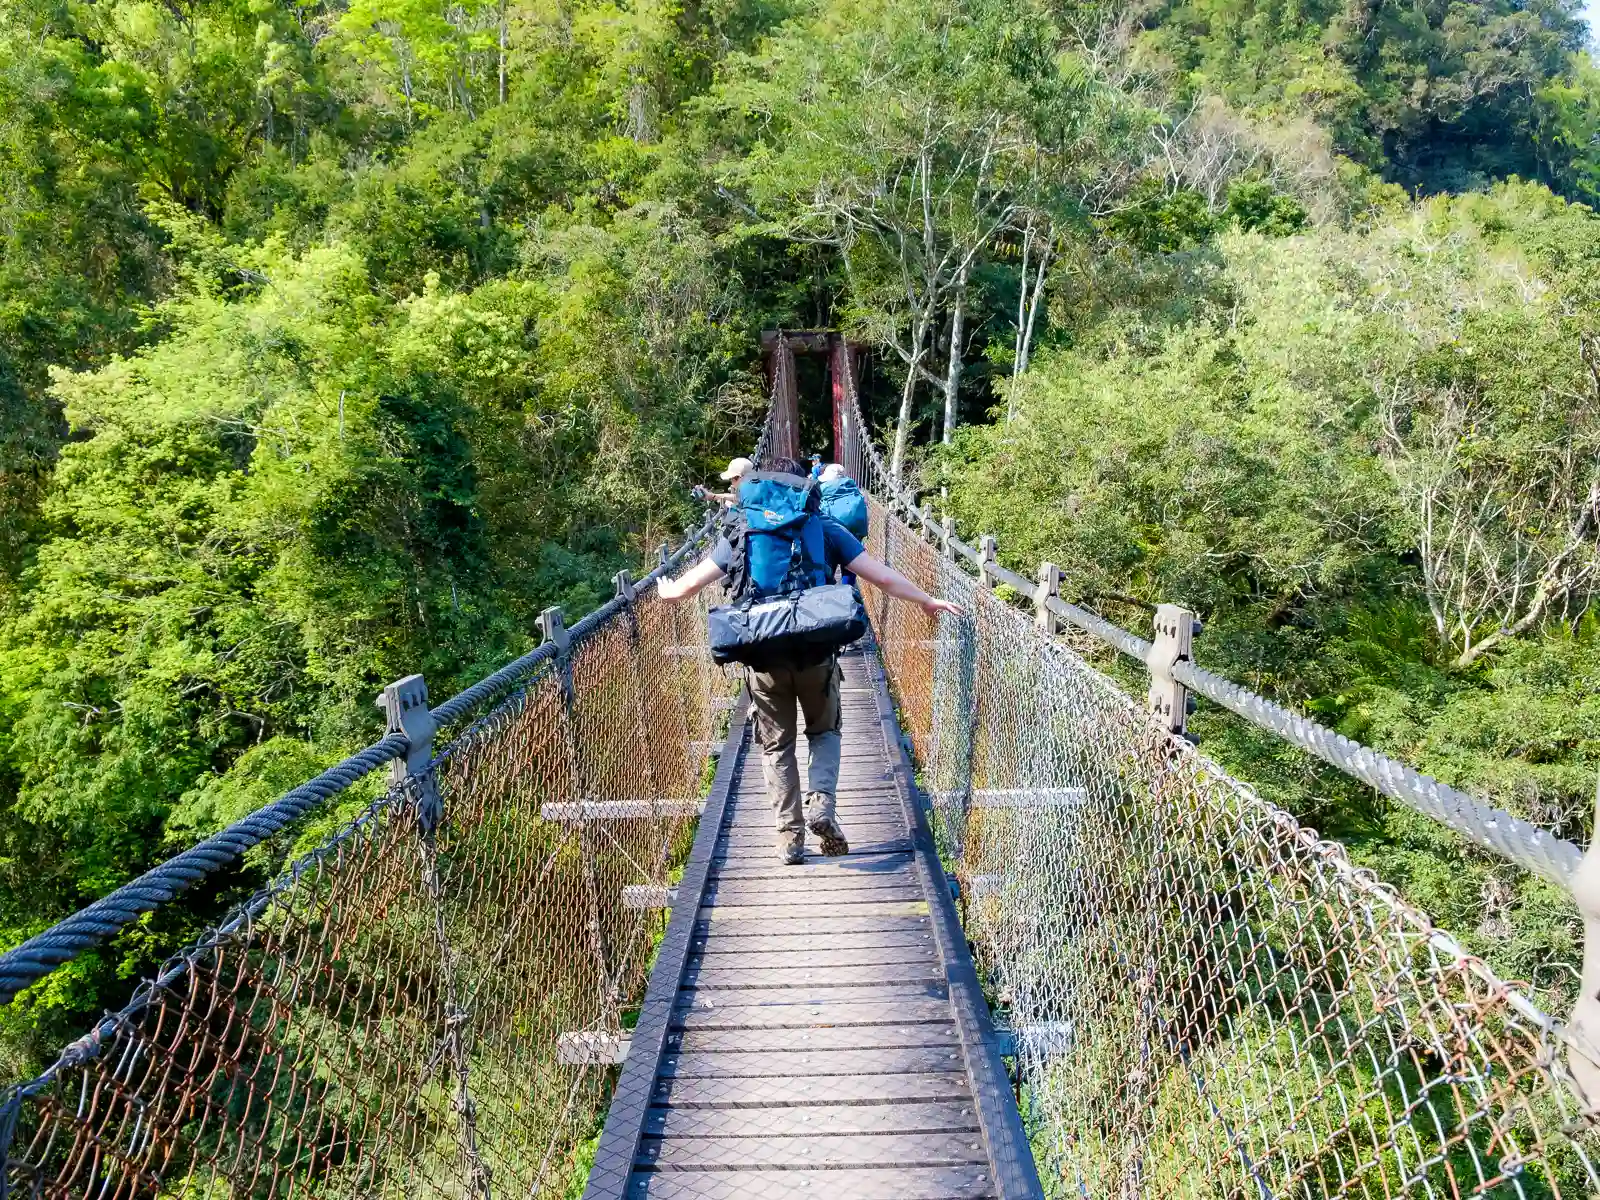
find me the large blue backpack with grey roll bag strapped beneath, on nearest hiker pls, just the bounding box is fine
[709,470,867,670]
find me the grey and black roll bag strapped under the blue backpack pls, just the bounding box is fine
[710,584,867,667]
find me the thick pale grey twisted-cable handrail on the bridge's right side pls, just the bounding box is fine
[845,361,1584,894]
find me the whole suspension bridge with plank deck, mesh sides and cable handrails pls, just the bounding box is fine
[0,334,1600,1200]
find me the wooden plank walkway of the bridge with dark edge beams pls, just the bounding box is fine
[586,650,1040,1200]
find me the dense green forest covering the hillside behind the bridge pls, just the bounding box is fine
[0,0,1600,1072]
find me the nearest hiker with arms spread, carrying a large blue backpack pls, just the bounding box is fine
[659,458,962,866]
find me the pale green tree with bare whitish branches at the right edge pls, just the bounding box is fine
[1366,195,1600,669]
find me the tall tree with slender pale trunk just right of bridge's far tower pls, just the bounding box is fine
[718,0,1014,477]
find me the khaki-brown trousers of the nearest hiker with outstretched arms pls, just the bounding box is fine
[747,658,843,834]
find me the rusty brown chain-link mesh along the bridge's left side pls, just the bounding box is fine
[0,569,736,1200]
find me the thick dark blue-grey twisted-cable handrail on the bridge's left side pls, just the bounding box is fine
[0,515,715,1005]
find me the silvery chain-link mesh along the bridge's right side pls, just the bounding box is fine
[846,364,1600,1198]
